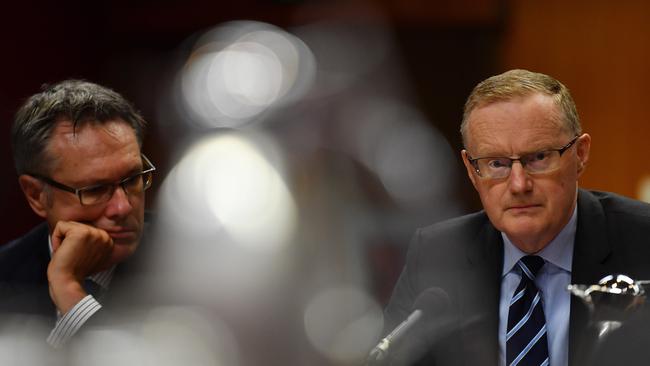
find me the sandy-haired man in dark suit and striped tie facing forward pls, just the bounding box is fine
[385,70,650,366]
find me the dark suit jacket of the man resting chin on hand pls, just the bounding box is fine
[0,213,151,327]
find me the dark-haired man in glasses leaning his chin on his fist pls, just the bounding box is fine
[0,80,155,347]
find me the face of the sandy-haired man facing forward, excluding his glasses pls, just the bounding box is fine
[462,93,590,253]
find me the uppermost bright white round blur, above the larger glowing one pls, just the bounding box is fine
[177,21,316,127]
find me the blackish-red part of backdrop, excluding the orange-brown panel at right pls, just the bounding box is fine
[0,0,504,242]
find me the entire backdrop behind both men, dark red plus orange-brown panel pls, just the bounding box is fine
[0,0,650,301]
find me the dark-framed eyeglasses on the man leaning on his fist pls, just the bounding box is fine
[32,155,156,206]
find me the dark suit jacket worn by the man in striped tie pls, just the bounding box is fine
[385,189,650,366]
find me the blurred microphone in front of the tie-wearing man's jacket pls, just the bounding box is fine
[366,287,450,365]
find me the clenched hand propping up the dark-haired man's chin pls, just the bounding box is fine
[47,221,113,314]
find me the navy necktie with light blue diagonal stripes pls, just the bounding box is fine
[506,255,549,366]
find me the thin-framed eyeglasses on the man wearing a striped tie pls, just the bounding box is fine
[467,136,580,179]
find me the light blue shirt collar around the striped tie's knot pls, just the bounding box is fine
[501,205,578,276]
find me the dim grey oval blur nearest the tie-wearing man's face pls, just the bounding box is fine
[340,98,456,209]
